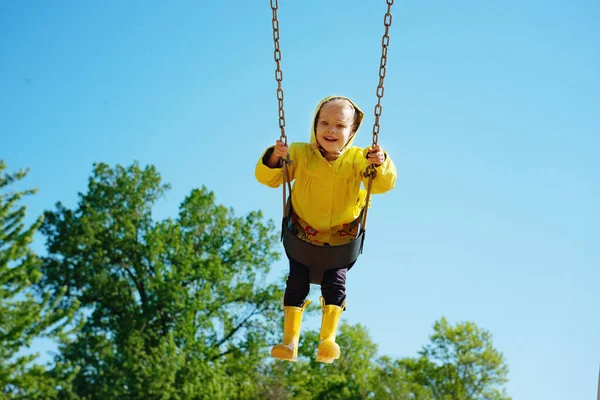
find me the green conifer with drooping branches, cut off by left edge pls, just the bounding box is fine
[0,160,77,399]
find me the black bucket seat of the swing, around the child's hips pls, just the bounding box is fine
[281,205,365,285]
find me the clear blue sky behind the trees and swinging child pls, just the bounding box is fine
[0,0,600,400]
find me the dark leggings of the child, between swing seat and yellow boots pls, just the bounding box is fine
[283,259,354,307]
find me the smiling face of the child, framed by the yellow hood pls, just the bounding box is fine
[315,99,356,161]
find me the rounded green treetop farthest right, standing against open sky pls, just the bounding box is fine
[400,318,510,400]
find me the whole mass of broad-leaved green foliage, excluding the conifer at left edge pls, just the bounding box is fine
[21,163,509,400]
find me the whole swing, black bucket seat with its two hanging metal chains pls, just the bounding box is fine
[271,0,394,284]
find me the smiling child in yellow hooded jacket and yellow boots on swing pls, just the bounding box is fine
[255,96,396,363]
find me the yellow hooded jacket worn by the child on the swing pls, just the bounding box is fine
[255,96,397,246]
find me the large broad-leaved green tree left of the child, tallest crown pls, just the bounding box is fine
[41,163,282,399]
